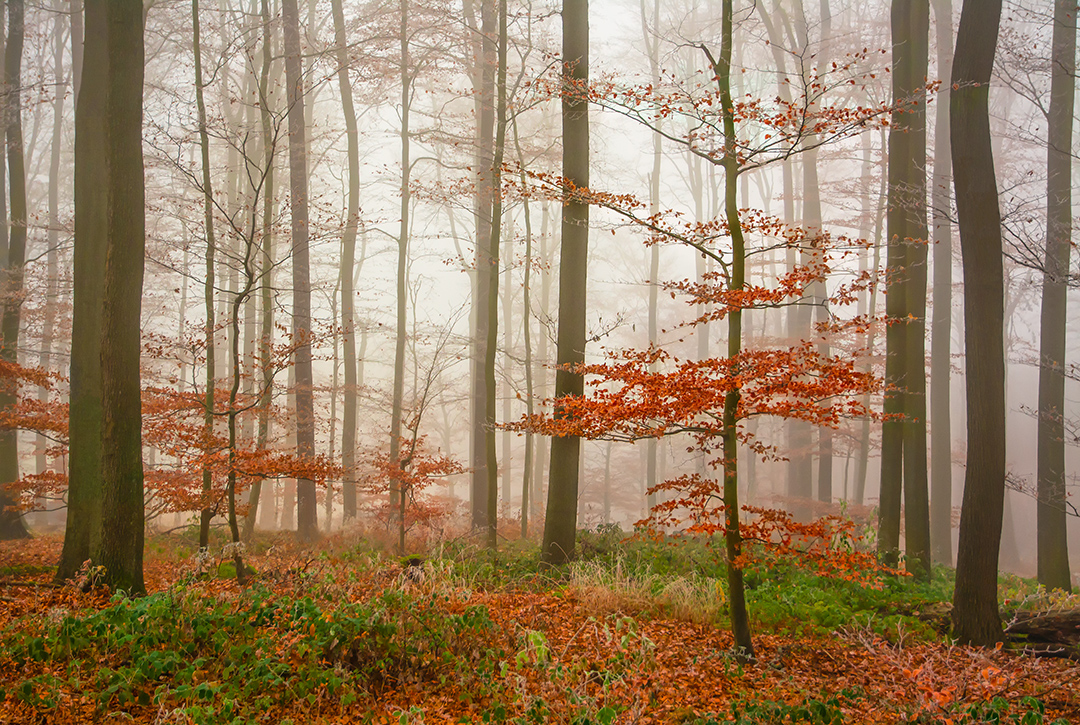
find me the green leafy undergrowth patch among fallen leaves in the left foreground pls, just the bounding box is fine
[0,587,505,724]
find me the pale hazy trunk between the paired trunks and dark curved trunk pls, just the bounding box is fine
[930,0,953,566]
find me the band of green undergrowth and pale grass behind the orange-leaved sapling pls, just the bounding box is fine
[408,525,1080,641]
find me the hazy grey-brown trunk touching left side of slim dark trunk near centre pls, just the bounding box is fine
[470,0,498,528]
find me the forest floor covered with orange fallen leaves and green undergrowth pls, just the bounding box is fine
[0,531,1080,725]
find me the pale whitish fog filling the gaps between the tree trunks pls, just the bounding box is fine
[0,0,1080,577]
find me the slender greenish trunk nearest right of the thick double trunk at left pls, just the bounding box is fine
[191,0,217,548]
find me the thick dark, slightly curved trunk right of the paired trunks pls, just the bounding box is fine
[949,0,1005,645]
